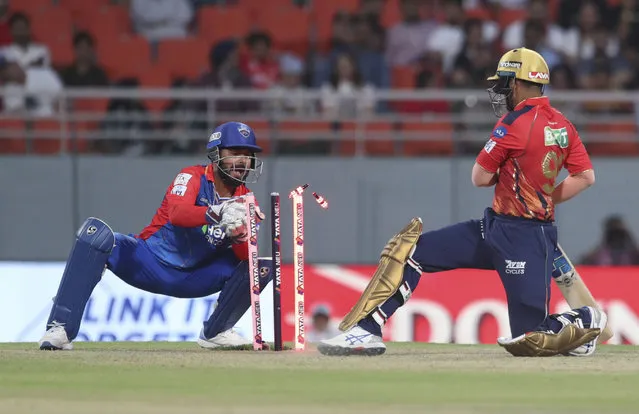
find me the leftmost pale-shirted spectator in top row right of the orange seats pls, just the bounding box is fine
[386,0,436,66]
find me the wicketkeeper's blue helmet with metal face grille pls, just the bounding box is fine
[206,122,262,185]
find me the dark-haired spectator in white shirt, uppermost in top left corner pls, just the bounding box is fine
[2,12,51,70]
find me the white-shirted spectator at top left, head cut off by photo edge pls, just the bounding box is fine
[131,0,193,41]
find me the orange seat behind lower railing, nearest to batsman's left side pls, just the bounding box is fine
[401,121,454,157]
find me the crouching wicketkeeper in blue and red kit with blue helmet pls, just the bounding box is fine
[39,122,273,350]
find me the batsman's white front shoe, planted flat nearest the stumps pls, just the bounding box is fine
[317,326,386,356]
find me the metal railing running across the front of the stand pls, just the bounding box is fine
[0,88,639,156]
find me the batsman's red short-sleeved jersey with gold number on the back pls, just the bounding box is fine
[477,97,592,221]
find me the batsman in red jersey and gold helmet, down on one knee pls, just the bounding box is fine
[318,48,607,356]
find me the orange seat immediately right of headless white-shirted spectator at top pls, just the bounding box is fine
[197,6,251,43]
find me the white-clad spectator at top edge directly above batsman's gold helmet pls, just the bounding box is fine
[503,0,563,50]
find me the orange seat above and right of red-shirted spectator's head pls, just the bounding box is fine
[256,7,310,55]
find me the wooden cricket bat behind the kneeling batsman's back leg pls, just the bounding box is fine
[553,245,614,343]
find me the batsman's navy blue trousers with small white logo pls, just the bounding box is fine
[413,208,557,337]
